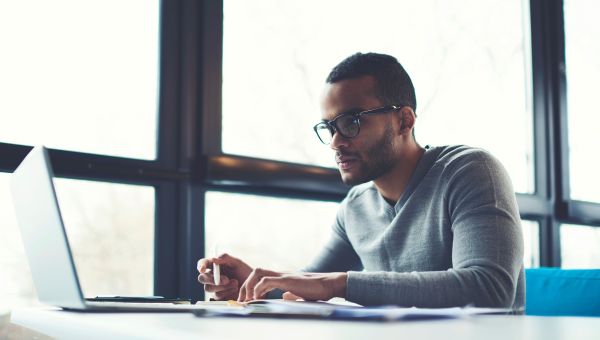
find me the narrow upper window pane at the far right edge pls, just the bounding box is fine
[564,0,600,202]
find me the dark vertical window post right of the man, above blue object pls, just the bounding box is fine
[530,0,568,266]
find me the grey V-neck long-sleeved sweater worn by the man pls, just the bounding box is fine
[305,146,525,309]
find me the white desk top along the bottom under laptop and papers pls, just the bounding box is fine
[11,309,600,340]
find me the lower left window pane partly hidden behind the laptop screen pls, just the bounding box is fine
[0,174,154,306]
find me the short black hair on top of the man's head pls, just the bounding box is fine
[326,52,417,112]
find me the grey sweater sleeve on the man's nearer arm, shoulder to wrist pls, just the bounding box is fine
[346,151,523,308]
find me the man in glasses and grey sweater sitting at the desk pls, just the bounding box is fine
[198,53,524,309]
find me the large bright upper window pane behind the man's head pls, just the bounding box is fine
[222,0,535,192]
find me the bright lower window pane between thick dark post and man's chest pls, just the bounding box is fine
[205,191,338,270]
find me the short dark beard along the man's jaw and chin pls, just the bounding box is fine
[342,125,395,186]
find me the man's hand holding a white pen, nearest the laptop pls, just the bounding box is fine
[198,254,252,300]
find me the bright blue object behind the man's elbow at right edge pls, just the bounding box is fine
[525,268,600,316]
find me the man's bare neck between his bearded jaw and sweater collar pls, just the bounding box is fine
[373,142,425,205]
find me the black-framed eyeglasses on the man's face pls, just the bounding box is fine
[313,105,402,145]
